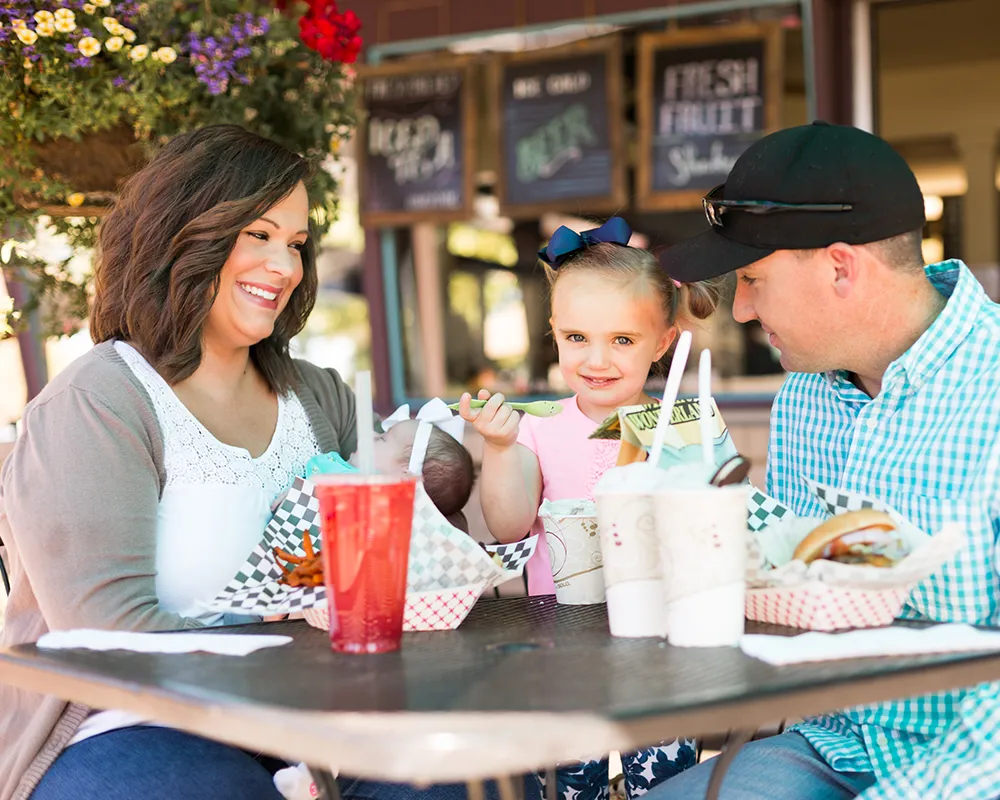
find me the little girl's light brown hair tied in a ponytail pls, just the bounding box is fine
[542,242,725,326]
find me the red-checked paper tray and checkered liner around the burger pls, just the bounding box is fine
[746,481,963,631]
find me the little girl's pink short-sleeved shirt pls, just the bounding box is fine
[517,395,618,595]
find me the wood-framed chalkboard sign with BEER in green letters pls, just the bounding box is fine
[492,36,625,218]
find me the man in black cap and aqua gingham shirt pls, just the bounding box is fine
[647,123,1000,800]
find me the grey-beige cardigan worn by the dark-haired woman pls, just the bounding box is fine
[0,342,357,800]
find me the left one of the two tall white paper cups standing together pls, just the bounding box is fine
[596,493,666,637]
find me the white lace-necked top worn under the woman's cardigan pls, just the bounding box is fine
[69,342,320,745]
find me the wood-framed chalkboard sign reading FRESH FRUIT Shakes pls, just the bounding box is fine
[636,25,782,211]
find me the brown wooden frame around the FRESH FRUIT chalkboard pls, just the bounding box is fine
[636,23,783,211]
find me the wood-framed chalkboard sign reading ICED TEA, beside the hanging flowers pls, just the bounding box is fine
[357,58,476,227]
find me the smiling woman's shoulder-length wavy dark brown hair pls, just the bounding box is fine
[90,125,317,392]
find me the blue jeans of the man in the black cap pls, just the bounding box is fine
[643,732,875,800]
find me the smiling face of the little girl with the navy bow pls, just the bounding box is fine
[550,272,675,420]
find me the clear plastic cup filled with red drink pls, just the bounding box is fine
[312,474,418,653]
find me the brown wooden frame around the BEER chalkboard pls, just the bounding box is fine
[490,34,628,219]
